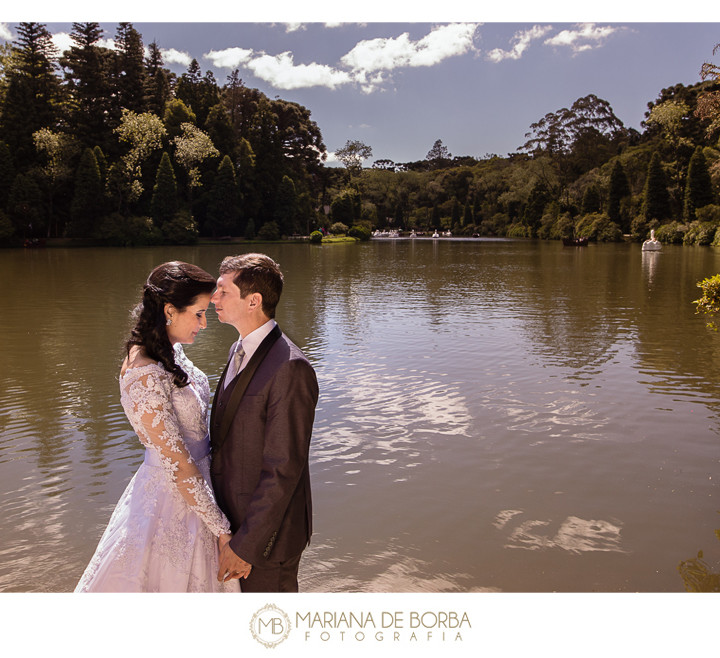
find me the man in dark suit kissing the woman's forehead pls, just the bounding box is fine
[210,254,318,592]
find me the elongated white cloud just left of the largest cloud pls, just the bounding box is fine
[246,52,352,89]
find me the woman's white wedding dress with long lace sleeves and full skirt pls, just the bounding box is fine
[75,345,240,592]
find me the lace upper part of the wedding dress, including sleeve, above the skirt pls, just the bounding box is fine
[120,345,230,537]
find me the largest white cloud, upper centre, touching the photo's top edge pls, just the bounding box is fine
[341,23,478,74]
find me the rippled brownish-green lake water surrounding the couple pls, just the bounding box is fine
[0,240,720,592]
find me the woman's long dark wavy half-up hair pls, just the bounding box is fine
[125,261,216,386]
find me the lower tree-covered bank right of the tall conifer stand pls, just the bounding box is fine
[332,80,720,246]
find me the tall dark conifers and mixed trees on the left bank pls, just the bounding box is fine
[0,22,326,244]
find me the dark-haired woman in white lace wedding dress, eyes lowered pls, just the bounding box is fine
[75,261,249,592]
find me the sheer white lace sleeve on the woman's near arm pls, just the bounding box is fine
[124,366,230,537]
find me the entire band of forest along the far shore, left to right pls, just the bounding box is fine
[0,22,720,245]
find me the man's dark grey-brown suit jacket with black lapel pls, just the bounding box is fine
[210,329,318,566]
